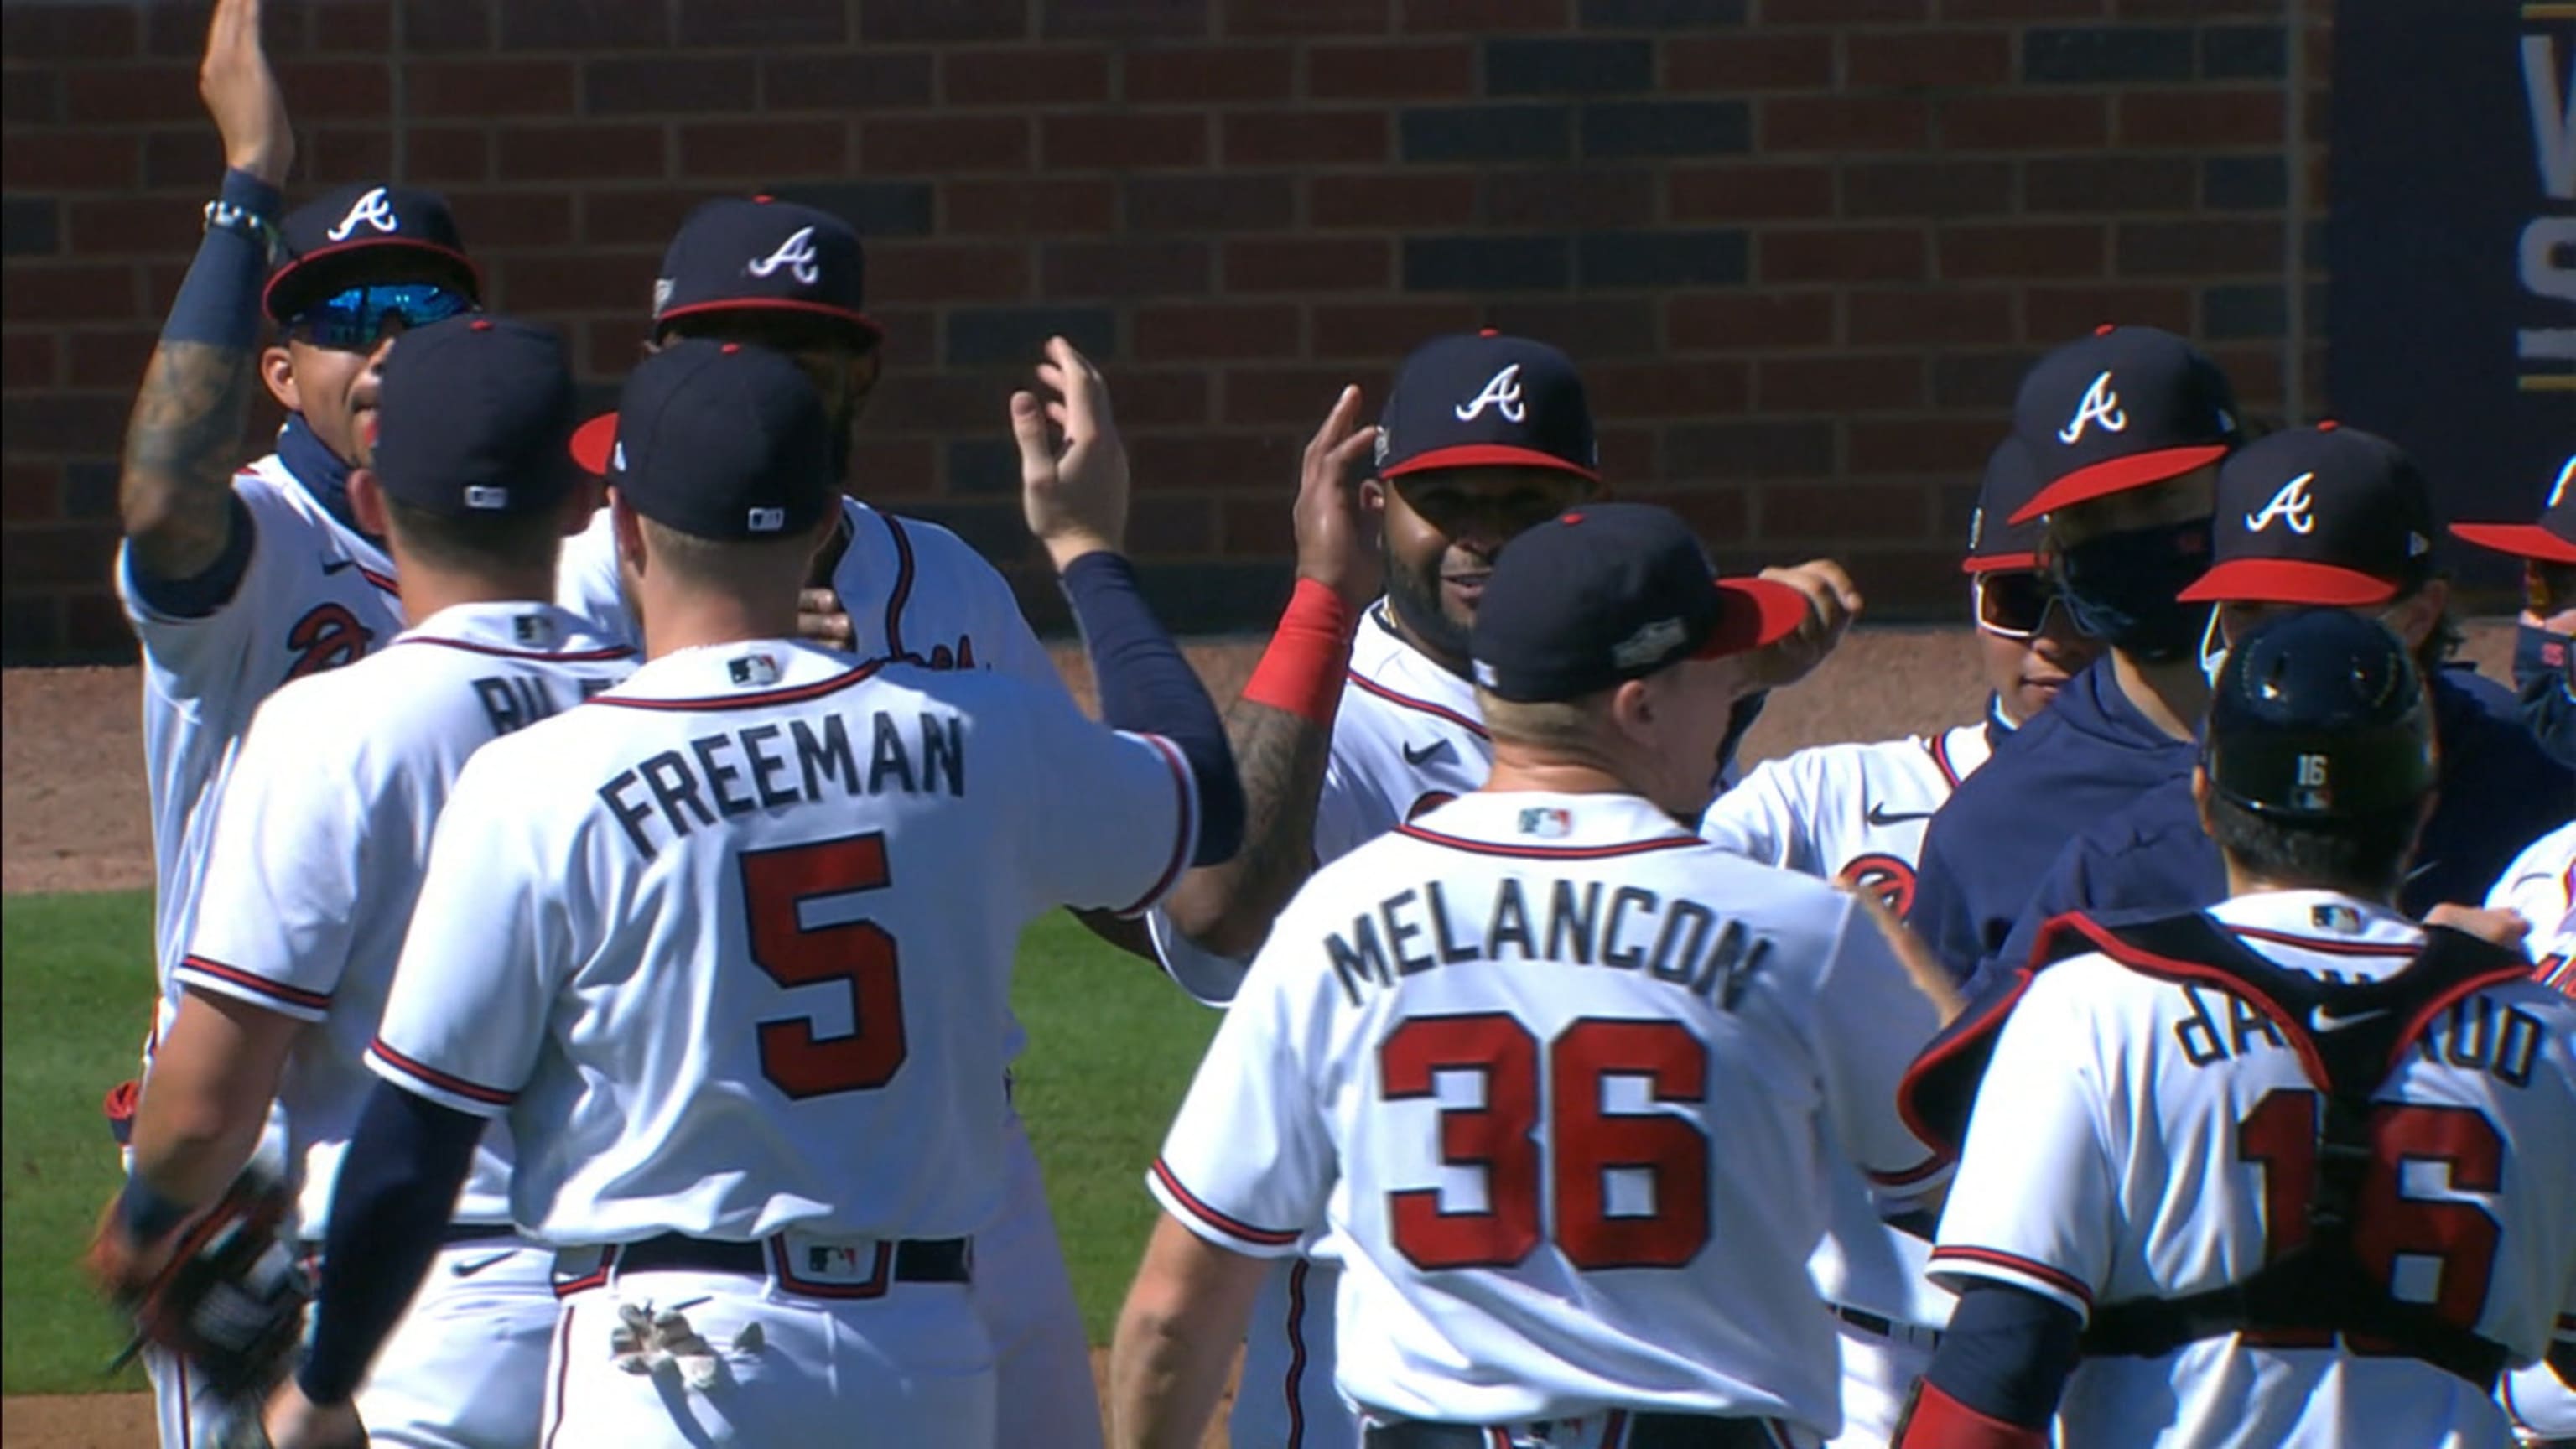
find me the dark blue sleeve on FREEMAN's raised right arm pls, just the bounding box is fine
[1064,554,1244,866]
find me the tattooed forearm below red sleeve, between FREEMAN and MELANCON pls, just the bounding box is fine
[1165,699,1332,957]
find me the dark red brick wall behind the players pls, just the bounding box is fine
[0,0,2329,662]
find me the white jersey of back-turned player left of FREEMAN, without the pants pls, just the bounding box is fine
[175,603,636,1238]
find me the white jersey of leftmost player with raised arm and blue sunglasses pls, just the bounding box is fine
[116,454,402,1010]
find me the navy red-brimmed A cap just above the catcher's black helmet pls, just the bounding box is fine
[2182,423,2434,606]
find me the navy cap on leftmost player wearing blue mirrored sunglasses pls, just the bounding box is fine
[260,180,481,325]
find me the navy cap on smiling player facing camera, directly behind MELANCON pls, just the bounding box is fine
[1375,330,1602,482]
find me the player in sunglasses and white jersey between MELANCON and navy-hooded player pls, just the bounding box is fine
[1701,439,2100,1449]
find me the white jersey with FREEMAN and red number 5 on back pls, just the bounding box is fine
[368,642,1195,1245]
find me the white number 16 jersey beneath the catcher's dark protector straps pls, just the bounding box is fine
[1932,890,2576,1449]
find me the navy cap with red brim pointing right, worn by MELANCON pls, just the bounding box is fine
[1468,503,1805,704]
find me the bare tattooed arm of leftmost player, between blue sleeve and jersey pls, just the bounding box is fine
[118,343,252,578]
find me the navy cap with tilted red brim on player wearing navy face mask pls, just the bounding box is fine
[2009,327,2241,523]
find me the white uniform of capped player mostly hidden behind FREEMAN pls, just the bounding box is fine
[557,497,1100,1449]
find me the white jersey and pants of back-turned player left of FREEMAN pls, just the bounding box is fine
[175,593,636,1449]
